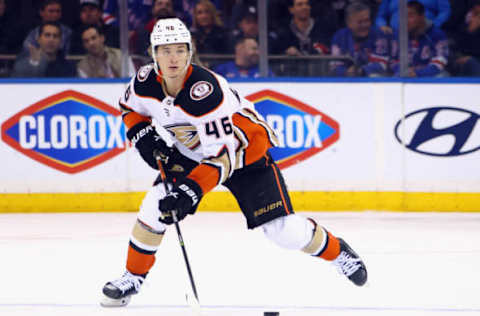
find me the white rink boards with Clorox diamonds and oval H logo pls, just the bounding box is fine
[0,82,480,198]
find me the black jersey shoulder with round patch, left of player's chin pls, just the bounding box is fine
[133,64,165,102]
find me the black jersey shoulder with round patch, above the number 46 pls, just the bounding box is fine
[175,65,223,117]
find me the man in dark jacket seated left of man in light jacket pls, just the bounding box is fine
[12,22,77,78]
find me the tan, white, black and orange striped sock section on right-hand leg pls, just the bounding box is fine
[302,218,340,261]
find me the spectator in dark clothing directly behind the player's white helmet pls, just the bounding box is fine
[132,0,175,56]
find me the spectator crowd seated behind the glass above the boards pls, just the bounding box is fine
[0,0,480,78]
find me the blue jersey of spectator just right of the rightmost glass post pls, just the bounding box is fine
[392,26,449,77]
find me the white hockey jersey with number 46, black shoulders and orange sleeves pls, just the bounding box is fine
[119,64,277,194]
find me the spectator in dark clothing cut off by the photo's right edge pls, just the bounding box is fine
[454,0,480,77]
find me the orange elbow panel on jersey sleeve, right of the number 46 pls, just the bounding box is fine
[232,113,272,165]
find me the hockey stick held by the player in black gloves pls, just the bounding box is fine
[153,150,200,315]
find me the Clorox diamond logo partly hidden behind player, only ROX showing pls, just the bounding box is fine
[247,90,340,168]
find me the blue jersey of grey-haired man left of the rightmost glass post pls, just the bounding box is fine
[331,26,390,76]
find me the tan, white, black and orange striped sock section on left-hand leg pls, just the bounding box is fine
[127,220,164,276]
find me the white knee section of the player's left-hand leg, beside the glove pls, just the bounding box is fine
[137,183,171,232]
